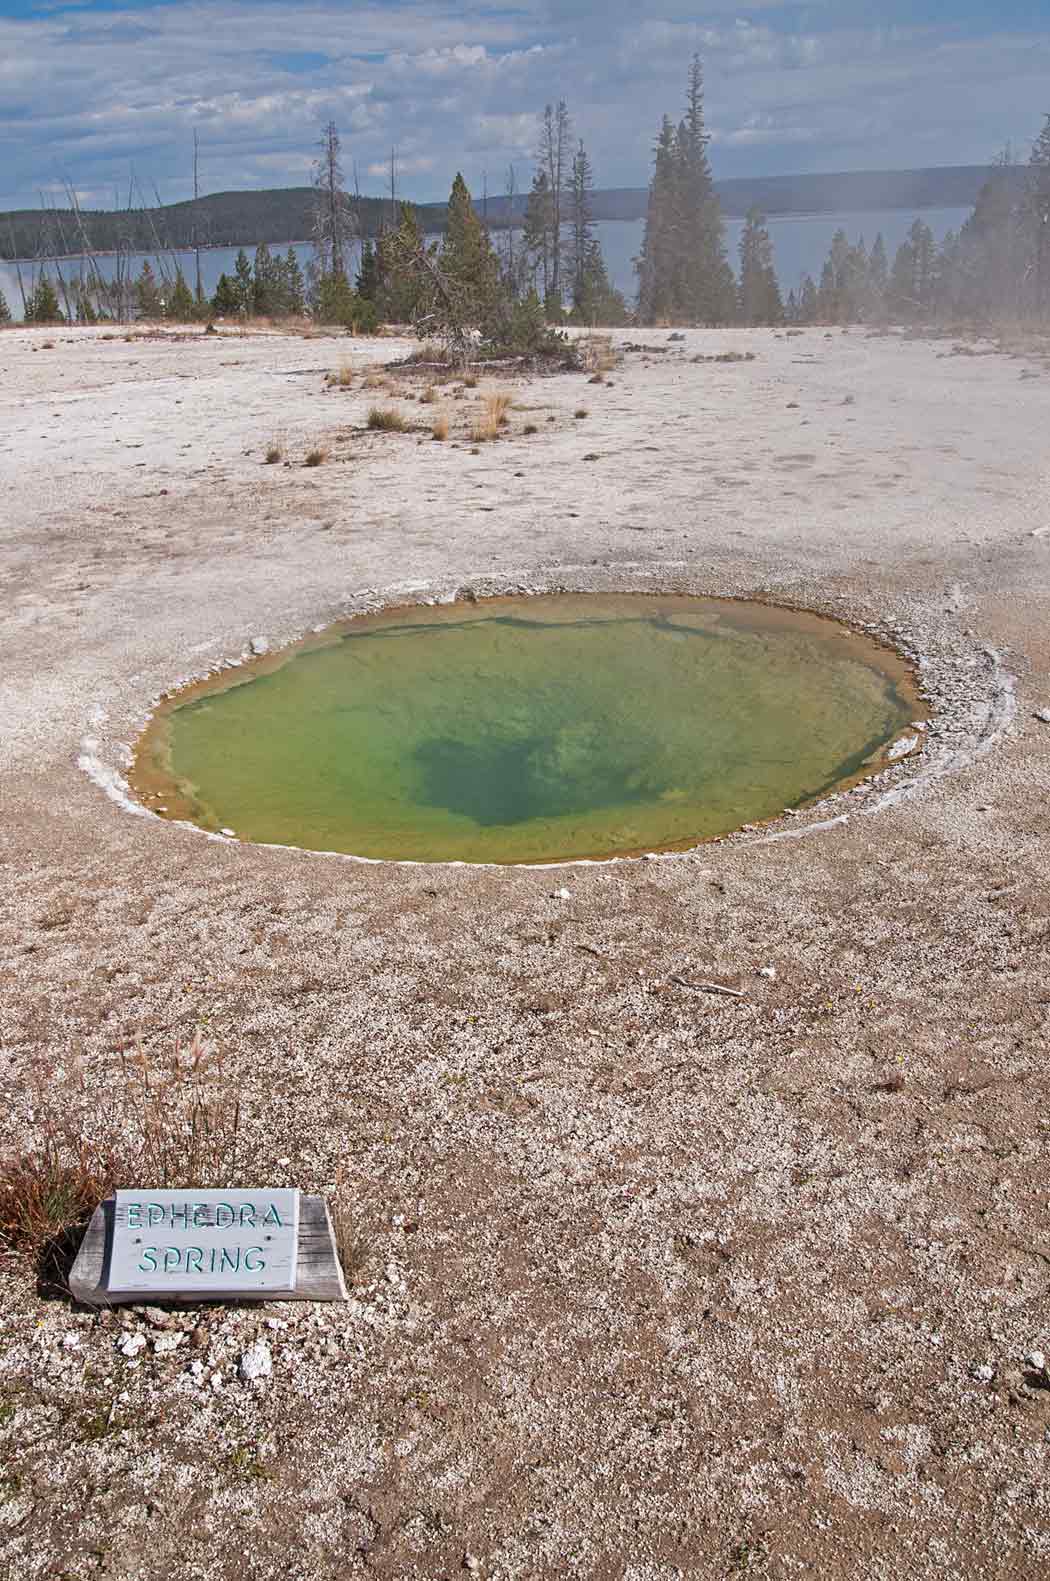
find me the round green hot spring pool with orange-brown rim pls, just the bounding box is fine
[136,594,916,862]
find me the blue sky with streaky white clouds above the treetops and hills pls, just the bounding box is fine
[0,0,1050,209]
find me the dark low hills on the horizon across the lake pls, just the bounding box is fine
[0,164,1023,258]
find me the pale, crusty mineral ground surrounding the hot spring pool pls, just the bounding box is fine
[0,329,1050,1581]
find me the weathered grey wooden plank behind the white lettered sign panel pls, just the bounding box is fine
[70,1197,348,1306]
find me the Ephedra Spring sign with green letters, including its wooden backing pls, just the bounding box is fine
[70,1186,346,1306]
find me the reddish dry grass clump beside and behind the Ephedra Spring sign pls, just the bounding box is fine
[0,1032,240,1287]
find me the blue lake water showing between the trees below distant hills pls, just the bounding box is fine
[0,209,971,318]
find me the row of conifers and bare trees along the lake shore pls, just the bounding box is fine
[0,57,1050,343]
